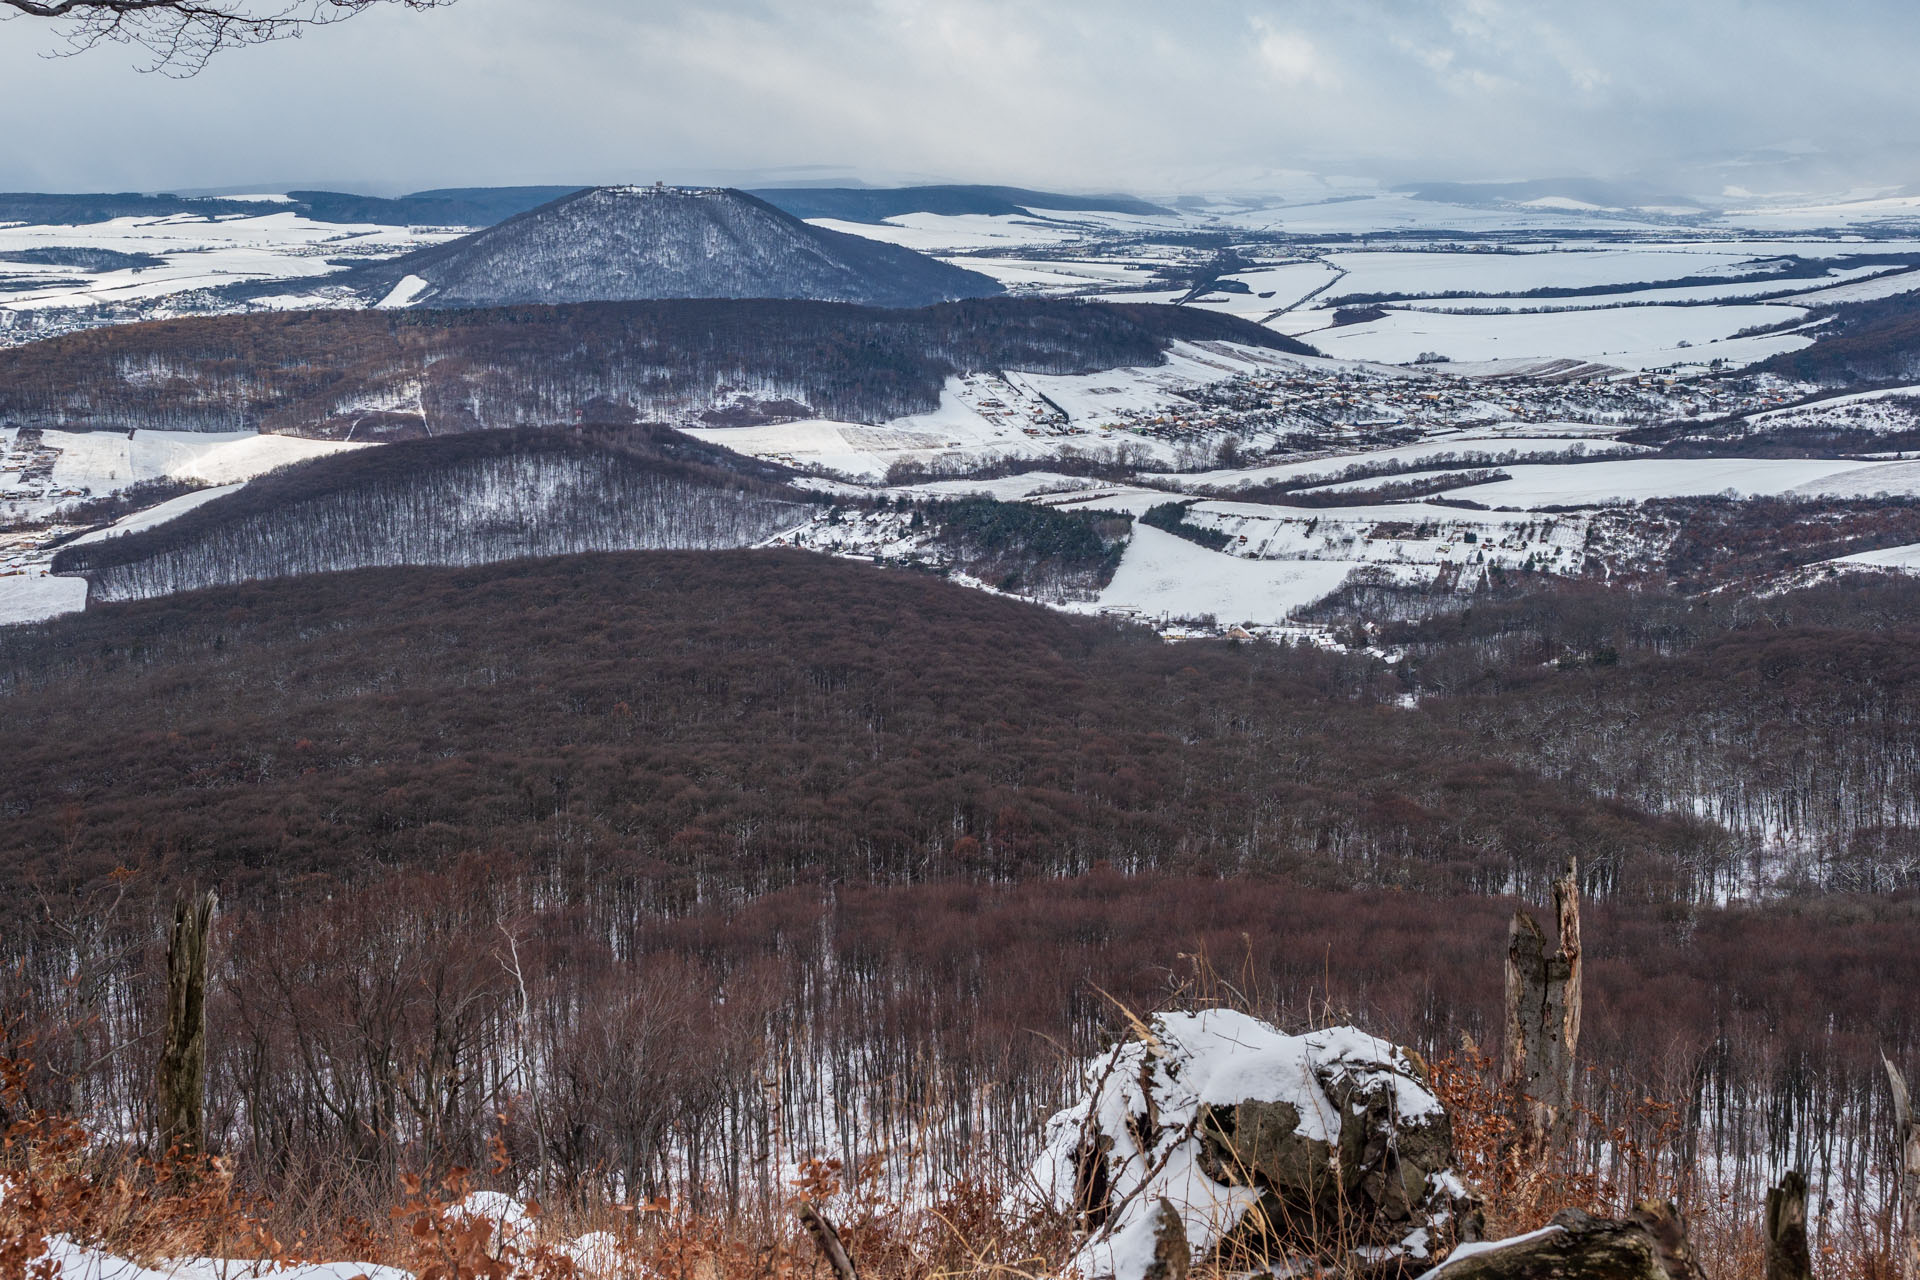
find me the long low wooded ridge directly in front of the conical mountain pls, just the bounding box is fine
[0,297,1311,439]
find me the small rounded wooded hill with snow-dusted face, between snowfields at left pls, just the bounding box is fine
[54,426,818,603]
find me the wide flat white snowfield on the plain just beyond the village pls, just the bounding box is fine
[1313,305,1812,368]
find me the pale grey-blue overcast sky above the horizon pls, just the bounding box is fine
[0,0,1920,196]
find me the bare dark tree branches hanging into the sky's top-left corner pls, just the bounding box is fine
[0,0,453,75]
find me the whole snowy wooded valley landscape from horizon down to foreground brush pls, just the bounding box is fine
[0,172,1920,1280]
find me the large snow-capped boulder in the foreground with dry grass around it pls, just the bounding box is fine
[1023,1009,1473,1280]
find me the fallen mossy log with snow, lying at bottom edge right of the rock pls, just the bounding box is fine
[1427,1201,1701,1280]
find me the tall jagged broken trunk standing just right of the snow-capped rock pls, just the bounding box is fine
[1505,864,1580,1146]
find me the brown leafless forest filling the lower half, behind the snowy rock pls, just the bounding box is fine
[0,553,1920,1276]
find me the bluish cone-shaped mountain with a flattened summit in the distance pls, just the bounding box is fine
[355,186,1002,307]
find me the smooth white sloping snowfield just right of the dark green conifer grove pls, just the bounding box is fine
[1100,524,1356,624]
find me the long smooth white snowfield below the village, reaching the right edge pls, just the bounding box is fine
[1420,459,1920,509]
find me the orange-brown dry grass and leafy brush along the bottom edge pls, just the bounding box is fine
[0,1046,1899,1280]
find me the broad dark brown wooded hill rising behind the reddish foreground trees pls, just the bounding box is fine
[0,551,1711,894]
